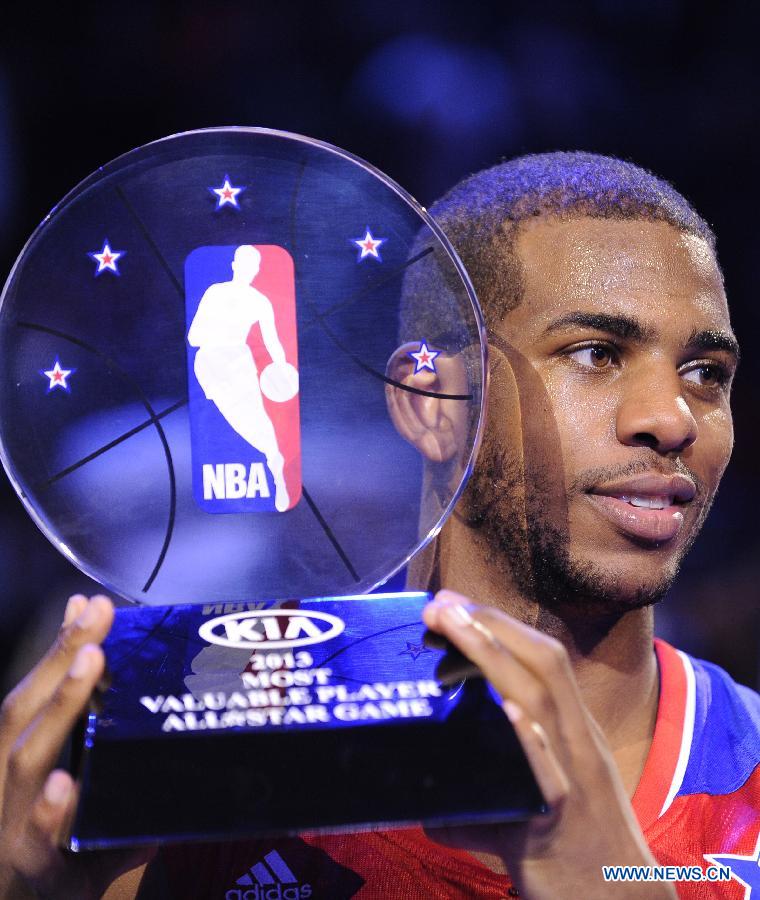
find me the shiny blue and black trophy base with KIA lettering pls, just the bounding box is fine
[63,593,545,850]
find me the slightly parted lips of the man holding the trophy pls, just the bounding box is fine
[586,473,697,544]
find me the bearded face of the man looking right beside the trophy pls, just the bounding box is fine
[472,218,736,611]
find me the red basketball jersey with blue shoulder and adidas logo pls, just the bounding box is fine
[160,640,760,900]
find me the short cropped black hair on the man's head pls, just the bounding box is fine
[408,151,715,334]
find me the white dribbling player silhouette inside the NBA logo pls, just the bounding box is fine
[187,245,290,512]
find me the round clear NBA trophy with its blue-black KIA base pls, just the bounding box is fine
[0,128,543,850]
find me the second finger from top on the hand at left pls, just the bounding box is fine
[4,644,105,817]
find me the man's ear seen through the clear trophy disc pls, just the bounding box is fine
[385,342,468,463]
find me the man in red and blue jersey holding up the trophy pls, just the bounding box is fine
[0,154,760,900]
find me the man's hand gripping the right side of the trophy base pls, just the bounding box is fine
[423,591,676,900]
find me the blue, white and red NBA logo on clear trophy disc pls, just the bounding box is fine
[185,244,301,513]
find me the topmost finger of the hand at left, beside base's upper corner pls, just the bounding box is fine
[0,595,113,740]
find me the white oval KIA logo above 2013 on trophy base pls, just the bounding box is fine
[198,609,346,650]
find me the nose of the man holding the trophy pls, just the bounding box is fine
[617,367,697,453]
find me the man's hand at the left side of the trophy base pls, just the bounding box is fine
[0,594,145,900]
